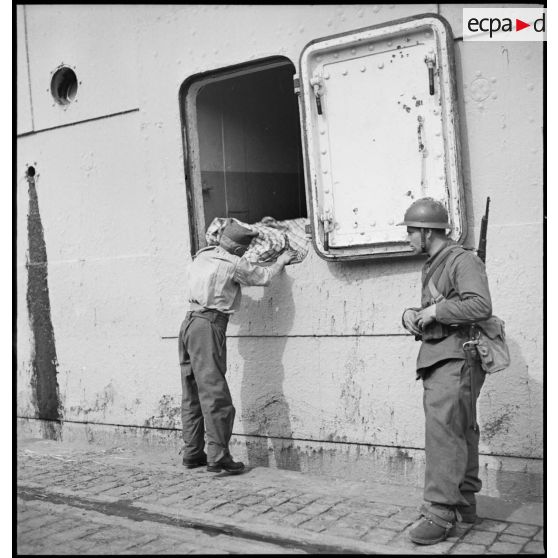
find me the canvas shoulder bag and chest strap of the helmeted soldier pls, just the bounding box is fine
[425,250,511,374]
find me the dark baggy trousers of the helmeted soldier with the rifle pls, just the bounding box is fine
[423,358,485,506]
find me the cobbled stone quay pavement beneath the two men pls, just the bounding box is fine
[17,438,544,554]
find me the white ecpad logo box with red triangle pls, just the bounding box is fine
[463,8,546,41]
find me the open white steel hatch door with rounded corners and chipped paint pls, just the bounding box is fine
[299,14,466,260]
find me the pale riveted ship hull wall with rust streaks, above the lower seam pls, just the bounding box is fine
[17,4,543,486]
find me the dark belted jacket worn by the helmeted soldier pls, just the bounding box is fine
[417,246,492,370]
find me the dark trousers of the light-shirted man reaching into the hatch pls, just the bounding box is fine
[178,310,235,463]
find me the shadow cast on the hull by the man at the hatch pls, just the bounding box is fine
[238,274,300,471]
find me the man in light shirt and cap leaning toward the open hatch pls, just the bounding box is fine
[178,220,296,473]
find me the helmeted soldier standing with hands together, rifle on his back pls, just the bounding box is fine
[399,198,492,544]
